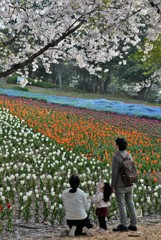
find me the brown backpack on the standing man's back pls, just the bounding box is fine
[118,153,138,186]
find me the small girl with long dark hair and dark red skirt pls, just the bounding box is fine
[91,180,112,233]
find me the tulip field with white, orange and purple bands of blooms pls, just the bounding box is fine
[0,95,161,231]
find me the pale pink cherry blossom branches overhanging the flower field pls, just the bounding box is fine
[0,0,161,78]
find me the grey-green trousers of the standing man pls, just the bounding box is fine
[116,186,137,226]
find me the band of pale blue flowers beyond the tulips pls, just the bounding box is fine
[0,88,161,119]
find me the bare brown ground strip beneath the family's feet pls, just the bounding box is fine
[0,215,161,240]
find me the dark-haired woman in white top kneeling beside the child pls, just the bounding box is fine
[62,175,93,237]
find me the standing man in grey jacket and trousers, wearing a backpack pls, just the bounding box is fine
[111,138,137,232]
